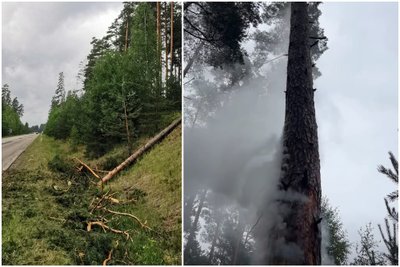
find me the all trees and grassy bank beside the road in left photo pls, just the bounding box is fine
[2,2,182,265]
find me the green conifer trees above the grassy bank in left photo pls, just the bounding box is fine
[45,2,181,159]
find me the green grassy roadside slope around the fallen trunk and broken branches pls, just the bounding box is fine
[2,128,181,265]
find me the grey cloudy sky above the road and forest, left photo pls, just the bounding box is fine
[2,2,122,126]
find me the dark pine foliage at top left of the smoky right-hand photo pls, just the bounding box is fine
[184,2,261,68]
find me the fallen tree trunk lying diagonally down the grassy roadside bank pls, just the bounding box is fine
[99,118,182,184]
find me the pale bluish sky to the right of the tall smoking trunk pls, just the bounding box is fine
[315,3,398,258]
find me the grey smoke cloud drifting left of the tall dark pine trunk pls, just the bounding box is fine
[184,3,298,264]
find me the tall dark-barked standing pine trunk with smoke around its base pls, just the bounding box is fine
[269,2,321,265]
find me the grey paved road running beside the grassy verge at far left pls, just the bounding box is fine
[1,134,39,171]
